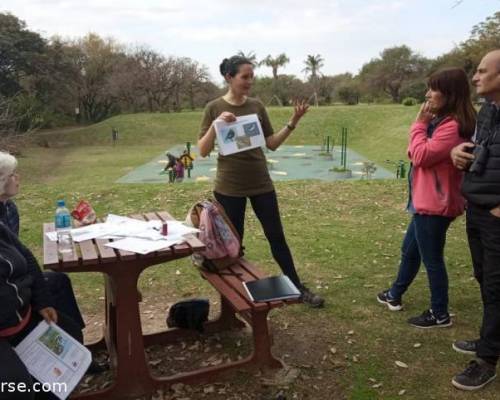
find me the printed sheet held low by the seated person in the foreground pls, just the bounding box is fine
[14,321,92,400]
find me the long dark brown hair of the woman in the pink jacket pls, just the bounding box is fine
[427,68,476,139]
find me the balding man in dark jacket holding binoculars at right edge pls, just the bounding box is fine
[451,49,500,390]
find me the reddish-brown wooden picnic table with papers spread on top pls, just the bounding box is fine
[43,211,210,400]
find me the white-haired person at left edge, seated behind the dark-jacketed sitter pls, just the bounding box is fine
[0,151,85,329]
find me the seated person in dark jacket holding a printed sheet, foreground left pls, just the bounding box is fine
[0,223,83,400]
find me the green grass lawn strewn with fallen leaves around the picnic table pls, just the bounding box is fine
[17,105,500,400]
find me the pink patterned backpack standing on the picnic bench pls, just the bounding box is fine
[186,200,241,269]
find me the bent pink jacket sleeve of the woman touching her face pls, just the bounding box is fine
[408,119,461,168]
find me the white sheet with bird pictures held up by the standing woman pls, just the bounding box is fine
[214,114,266,156]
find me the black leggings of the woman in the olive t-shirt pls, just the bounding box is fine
[214,190,302,288]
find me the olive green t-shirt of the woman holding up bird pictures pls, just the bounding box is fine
[200,97,274,197]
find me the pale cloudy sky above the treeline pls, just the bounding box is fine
[0,0,500,82]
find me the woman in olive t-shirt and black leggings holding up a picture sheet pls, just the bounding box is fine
[198,56,324,307]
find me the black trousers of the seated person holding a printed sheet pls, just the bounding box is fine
[0,311,83,400]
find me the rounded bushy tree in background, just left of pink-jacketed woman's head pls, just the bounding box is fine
[360,45,429,103]
